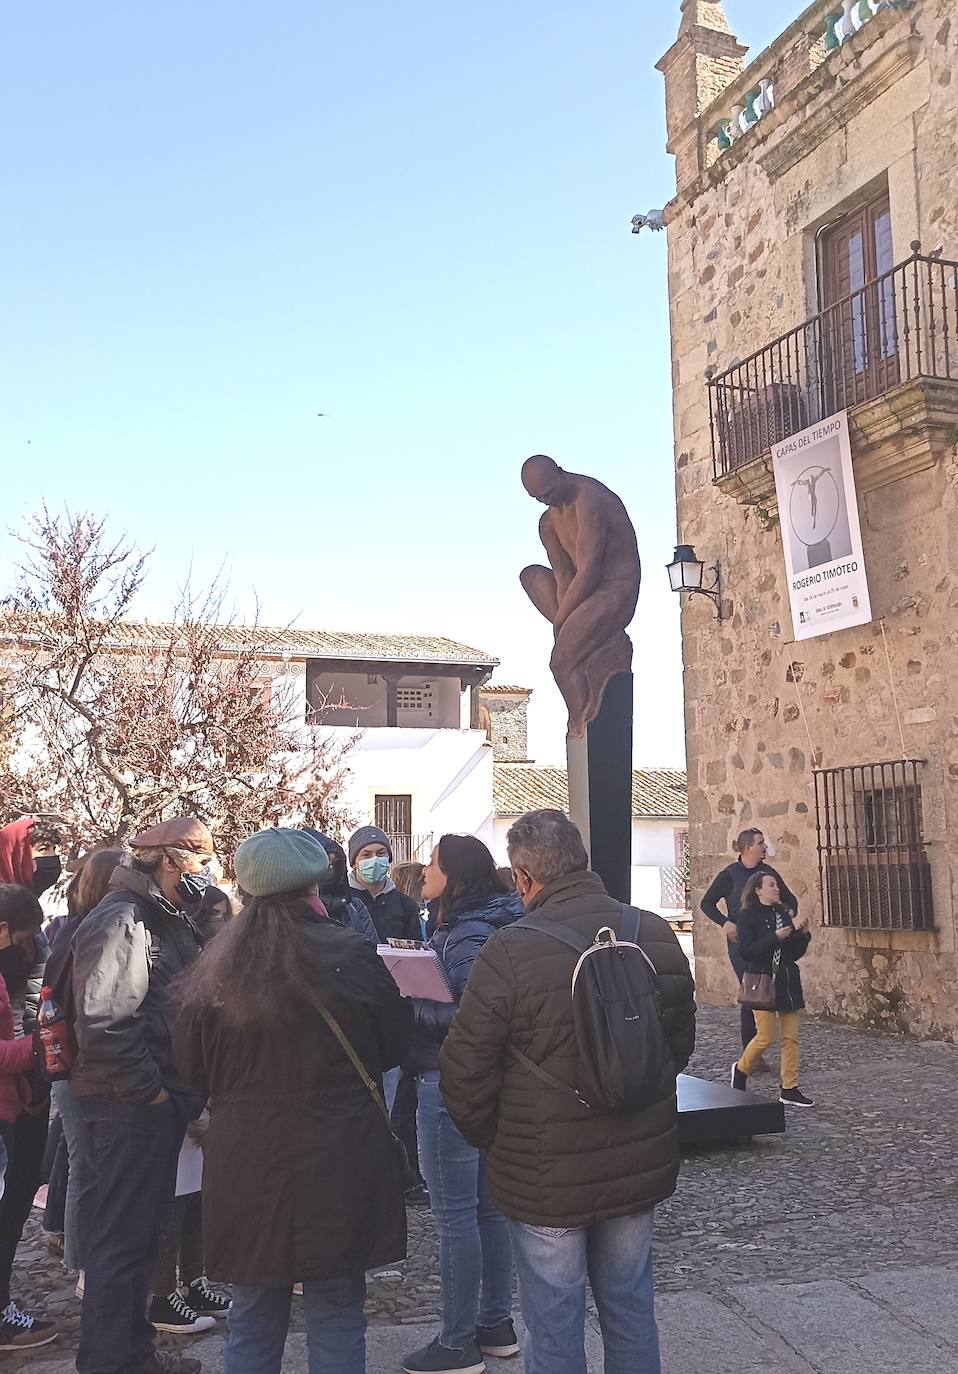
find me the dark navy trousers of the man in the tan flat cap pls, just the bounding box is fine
[73,1096,186,1374]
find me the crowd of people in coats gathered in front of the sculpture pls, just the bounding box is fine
[0,811,703,1374]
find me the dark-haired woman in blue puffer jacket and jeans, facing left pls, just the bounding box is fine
[403,835,524,1374]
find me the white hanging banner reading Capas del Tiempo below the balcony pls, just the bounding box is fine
[771,411,871,639]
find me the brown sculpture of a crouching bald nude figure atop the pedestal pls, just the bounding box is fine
[520,453,642,739]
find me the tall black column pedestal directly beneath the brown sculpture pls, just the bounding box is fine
[566,673,632,903]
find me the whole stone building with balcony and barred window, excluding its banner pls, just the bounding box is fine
[660,0,958,1040]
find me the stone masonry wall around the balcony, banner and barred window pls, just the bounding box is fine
[660,0,958,1040]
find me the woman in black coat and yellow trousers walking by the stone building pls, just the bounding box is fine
[731,872,815,1107]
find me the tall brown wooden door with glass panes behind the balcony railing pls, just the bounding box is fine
[821,191,899,415]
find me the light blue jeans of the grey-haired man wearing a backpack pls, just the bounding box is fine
[509,1212,661,1374]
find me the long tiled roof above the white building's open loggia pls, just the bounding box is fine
[21,620,499,668]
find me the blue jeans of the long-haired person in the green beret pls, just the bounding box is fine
[223,1274,366,1374]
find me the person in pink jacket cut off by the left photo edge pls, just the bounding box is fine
[0,882,58,1351]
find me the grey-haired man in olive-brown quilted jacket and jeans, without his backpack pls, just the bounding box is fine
[440,811,695,1374]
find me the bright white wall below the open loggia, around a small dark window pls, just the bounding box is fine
[328,727,492,844]
